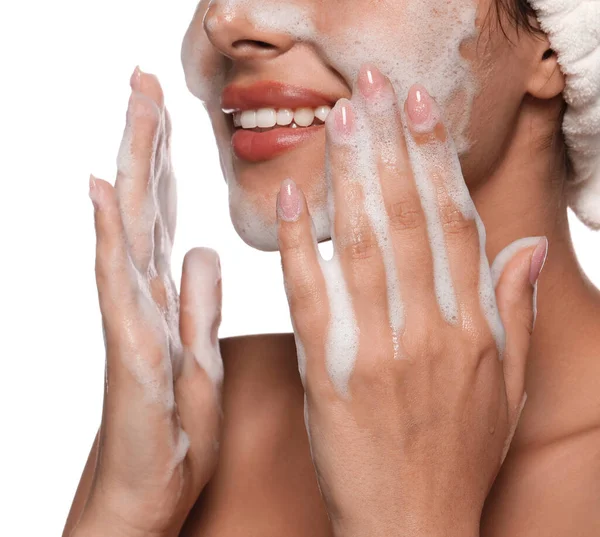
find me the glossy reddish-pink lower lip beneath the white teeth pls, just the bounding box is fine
[231,125,323,162]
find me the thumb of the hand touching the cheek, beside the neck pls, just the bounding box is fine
[492,237,548,421]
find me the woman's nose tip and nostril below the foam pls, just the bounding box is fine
[204,2,295,60]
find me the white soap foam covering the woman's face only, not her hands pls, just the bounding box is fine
[182,0,477,250]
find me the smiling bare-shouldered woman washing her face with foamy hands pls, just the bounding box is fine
[65,0,600,536]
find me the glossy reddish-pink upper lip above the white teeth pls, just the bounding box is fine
[221,80,338,113]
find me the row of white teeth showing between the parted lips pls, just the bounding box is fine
[233,106,331,129]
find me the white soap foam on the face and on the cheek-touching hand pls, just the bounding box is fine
[183,0,504,395]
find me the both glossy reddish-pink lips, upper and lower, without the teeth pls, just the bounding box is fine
[221,81,337,162]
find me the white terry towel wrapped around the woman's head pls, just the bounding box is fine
[530,0,600,229]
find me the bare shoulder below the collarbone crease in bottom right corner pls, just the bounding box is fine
[481,427,600,537]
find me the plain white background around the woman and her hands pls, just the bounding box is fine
[0,0,600,537]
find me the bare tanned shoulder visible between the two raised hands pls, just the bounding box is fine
[181,334,329,537]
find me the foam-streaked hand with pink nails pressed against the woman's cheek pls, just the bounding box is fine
[278,67,547,537]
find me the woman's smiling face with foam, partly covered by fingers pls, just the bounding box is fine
[182,0,531,250]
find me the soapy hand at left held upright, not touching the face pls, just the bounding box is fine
[72,68,223,537]
